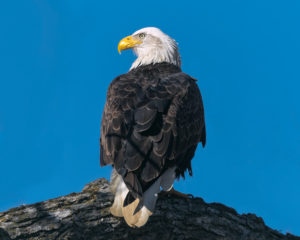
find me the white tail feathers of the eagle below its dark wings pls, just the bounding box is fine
[110,168,175,227]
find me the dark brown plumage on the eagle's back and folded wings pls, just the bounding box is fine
[100,63,206,205]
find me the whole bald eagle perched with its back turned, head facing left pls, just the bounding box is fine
[100,27,206,227]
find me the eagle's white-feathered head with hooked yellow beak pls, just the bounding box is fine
[118,27,181,70]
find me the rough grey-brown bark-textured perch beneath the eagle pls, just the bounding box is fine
[0,178,300,240]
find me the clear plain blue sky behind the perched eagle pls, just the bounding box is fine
[0,0,300,235]
